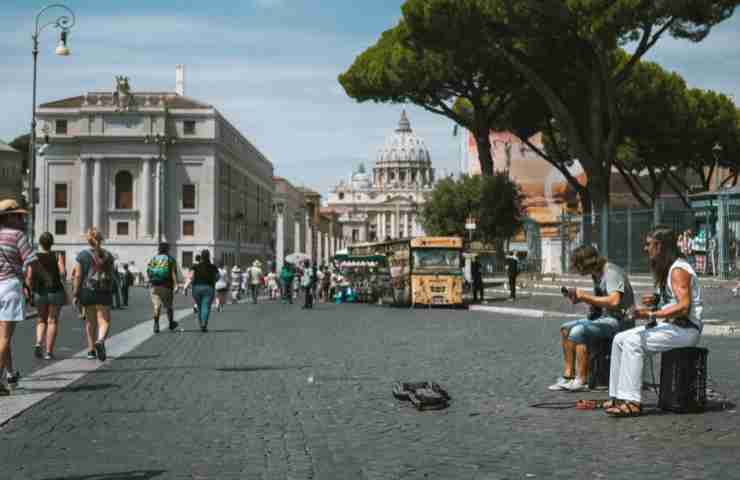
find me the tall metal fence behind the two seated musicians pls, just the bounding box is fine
[560,195,740,279]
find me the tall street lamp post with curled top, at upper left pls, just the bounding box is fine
[28,3,75,244]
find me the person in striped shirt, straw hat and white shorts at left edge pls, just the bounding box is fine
[0,200,37,396]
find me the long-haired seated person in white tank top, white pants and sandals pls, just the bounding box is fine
[605,226,704,417]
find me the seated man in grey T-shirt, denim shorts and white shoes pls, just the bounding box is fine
[548,246,635,392]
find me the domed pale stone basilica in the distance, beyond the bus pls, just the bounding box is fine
[327,111,435,243]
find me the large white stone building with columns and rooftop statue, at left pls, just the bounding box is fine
[35,66,274,276]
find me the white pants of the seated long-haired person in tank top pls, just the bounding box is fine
[609,323,699,403]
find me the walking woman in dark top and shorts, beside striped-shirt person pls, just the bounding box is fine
[28,232,67,360]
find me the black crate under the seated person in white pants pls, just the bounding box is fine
[658,347,709,413]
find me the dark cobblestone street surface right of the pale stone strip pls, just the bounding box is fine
[0,298,740,480]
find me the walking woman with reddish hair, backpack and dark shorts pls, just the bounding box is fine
[72,227,113,362]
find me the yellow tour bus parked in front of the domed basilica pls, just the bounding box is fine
[349,237,463,306]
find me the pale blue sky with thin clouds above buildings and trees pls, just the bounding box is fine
[0,0,740,195]
